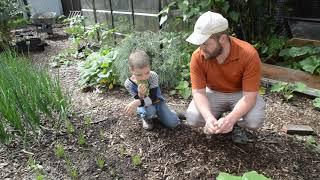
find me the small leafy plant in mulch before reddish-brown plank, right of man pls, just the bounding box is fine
[271,82,306,101]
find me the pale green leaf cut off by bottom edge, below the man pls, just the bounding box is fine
[217,171,271,180]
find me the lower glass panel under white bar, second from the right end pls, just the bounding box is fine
[113,14,133,34]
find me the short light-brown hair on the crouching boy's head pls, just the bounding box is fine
[129,50,150,69]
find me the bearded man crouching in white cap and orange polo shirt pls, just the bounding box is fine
[186,11,265,143]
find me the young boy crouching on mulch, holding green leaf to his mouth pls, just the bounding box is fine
[124,50,180,130]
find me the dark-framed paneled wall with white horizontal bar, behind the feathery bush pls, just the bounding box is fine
[81,0,162,35]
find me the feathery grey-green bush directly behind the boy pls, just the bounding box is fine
[113,31,193,88]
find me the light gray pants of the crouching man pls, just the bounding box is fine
[186,88,266,130]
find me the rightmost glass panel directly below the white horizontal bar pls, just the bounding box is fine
[134,16,159,32]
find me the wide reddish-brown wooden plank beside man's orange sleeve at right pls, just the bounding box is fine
[262,63,320,90]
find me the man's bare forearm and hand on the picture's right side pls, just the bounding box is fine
[216,92,258,133]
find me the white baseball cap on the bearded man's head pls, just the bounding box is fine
[186,11,228,45]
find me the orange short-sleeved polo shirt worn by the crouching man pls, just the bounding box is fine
[190,37,261,93]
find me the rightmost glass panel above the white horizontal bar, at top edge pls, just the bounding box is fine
[133,0,159,14]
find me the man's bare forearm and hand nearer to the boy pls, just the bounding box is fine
[192,89,217,133]
